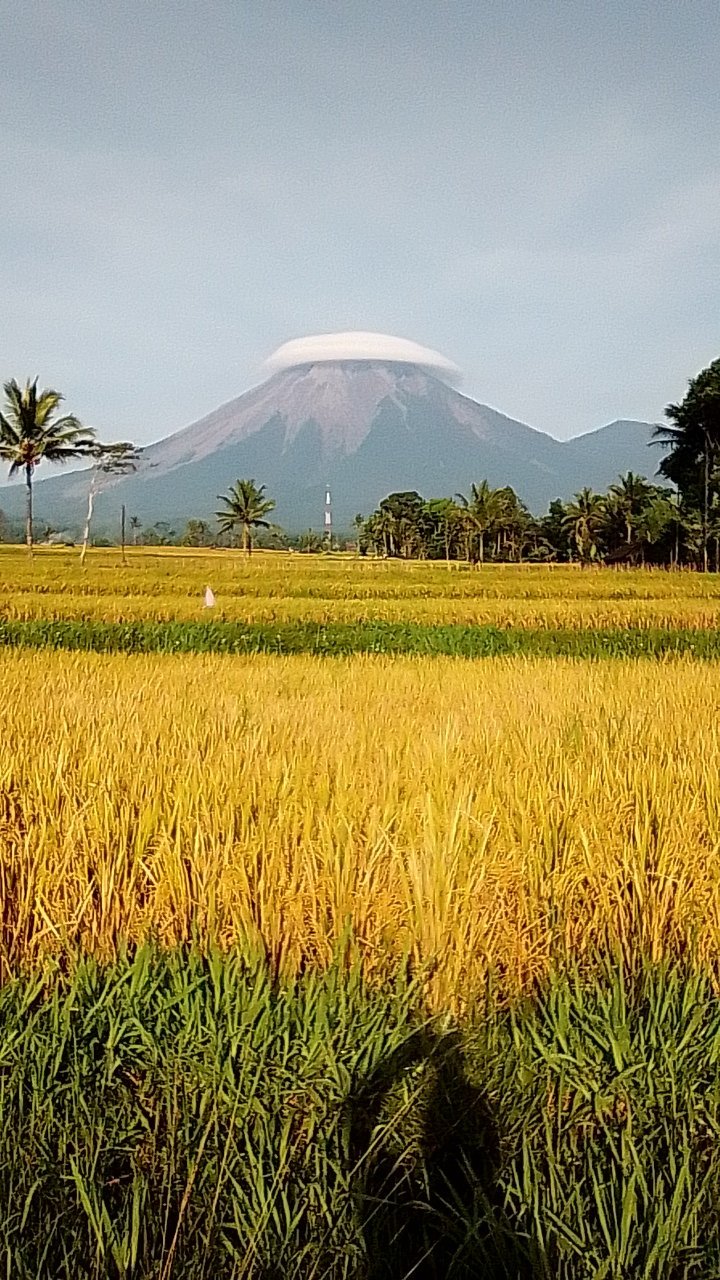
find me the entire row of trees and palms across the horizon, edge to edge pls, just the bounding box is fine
[0,360,720,572]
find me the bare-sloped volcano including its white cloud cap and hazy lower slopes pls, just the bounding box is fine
[1,334,659,531]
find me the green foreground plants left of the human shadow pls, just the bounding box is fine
[0,950,411,1280]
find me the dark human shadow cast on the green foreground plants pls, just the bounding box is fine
[348,1029,537,1280]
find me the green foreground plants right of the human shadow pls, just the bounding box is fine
[486,960,720,1280]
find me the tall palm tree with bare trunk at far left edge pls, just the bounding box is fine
[0,378,95,554]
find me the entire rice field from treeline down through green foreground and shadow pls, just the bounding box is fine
[0,548,720,1280]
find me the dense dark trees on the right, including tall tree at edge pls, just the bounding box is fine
[357,360,720,572]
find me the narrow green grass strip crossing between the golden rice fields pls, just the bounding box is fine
[0,620,720,659]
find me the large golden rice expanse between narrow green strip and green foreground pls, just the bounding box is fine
[0,652,720,1007]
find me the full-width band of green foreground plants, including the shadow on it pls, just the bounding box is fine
[0,947,720,1280]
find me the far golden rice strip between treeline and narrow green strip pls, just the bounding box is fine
[0,547,720,627]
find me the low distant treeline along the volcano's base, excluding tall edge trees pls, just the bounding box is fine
[0,471,707,570]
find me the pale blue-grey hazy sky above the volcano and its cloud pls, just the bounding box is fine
[0,0,720,443]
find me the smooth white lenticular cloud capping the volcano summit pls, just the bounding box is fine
[265,333,460,383]
